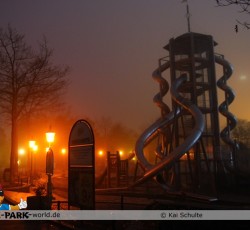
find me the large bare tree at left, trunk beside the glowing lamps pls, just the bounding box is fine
[0,26,68,180]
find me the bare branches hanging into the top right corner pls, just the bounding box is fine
[216,0,250,32]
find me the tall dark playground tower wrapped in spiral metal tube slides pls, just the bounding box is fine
[134,32,237,194]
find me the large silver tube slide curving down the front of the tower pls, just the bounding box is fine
[133,71,204,189]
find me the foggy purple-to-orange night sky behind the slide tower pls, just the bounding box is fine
[0,0,250,129]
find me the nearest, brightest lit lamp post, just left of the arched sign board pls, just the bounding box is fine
[46,131,55,205]
